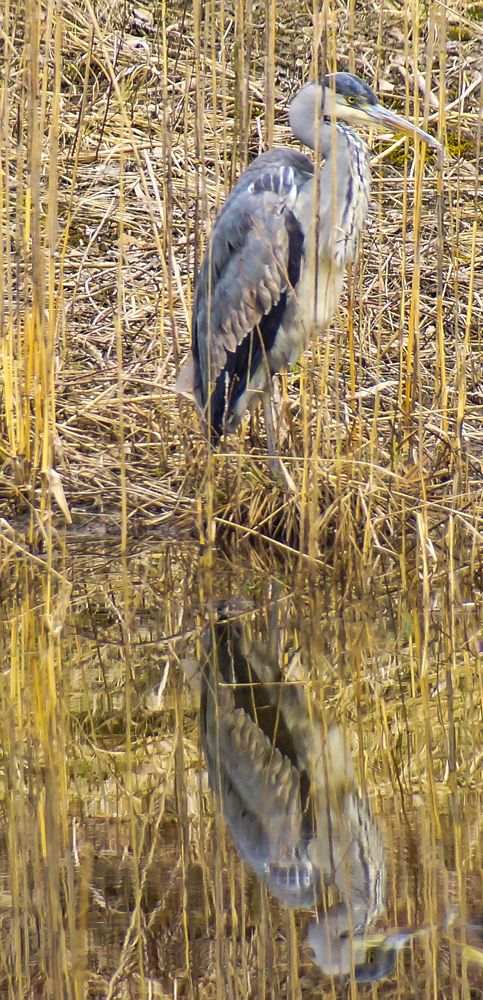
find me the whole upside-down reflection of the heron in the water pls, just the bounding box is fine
[201,613,407,981]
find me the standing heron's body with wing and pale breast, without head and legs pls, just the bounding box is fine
[193,126,369,437]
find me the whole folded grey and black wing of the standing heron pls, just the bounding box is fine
[193,150,313,436]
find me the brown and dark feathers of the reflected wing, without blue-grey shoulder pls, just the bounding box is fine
[201,620,309,854]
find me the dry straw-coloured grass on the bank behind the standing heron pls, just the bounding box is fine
[0,3,482,550]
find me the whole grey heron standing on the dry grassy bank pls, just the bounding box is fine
[177,73,439,468]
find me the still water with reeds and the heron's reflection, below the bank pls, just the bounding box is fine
[0,539,483,1000]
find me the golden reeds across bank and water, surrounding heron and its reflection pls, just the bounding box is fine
[0,0,483,1000]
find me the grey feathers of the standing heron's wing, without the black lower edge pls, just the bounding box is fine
[193,150,313,406]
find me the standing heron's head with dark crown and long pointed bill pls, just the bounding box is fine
[289,73,440,148]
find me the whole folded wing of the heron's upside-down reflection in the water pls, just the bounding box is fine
[201,618,320,906]
